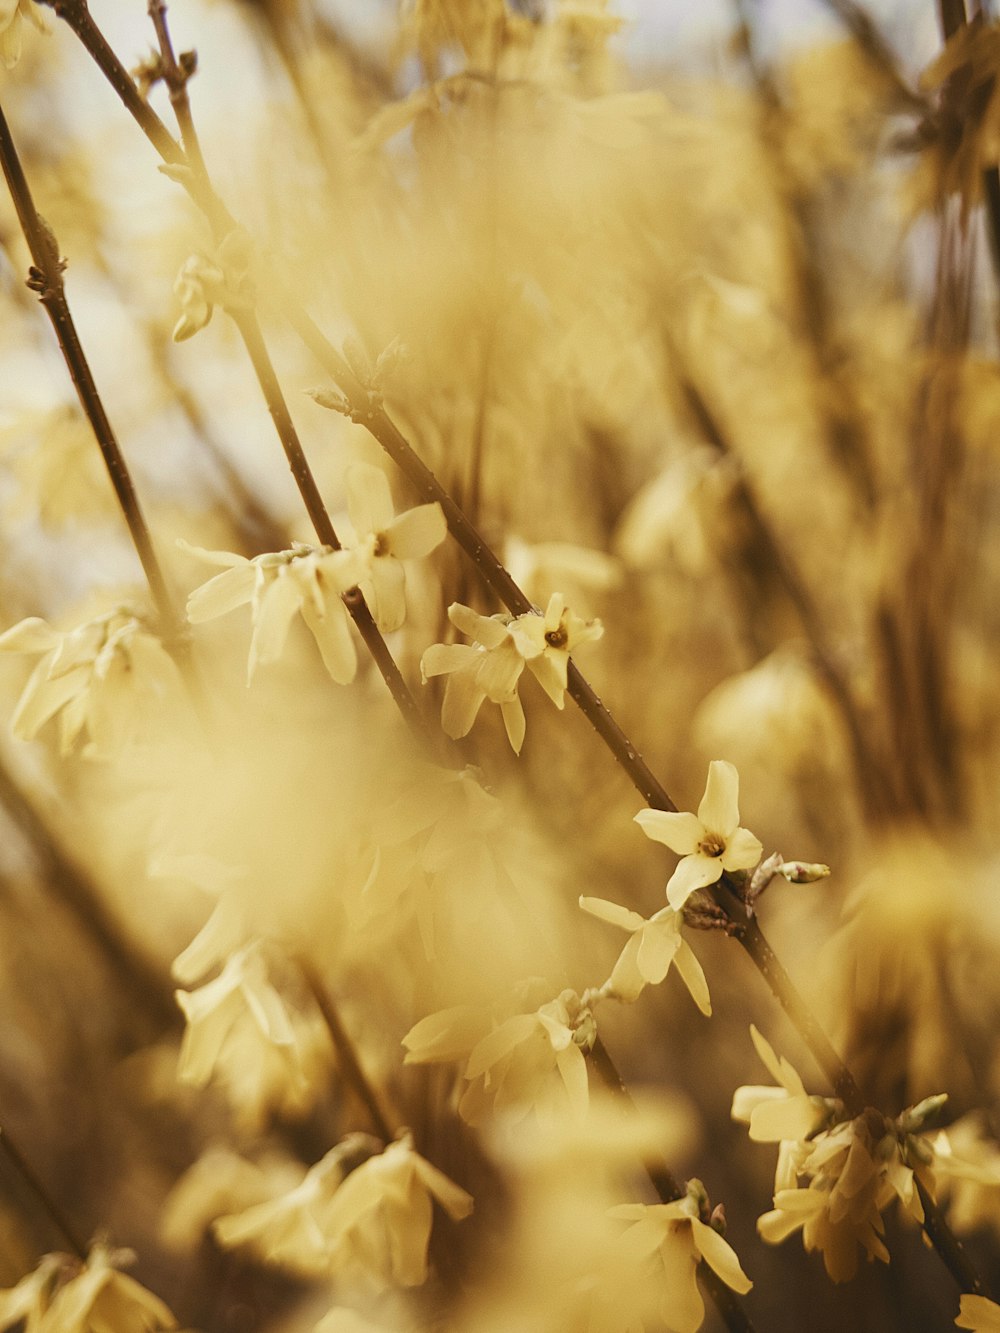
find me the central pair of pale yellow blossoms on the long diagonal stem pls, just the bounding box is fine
[420,593,604,753]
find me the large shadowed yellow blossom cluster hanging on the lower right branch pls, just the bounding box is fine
[732,1028,945,1282]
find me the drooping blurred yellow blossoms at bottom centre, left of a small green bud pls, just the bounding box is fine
[403,990,597,1124]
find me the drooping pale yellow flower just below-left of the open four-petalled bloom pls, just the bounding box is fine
[580,897,712,1016]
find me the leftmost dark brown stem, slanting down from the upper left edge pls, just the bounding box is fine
[0,107,180,643]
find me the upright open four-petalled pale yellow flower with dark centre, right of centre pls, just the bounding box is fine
[636,760,764,912]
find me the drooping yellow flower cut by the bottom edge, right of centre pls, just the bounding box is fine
[611,1180,753,1333]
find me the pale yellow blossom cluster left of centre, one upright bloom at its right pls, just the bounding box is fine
[184,463,447,685]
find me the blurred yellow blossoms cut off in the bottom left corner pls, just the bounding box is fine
[0,1244,177,1333]
